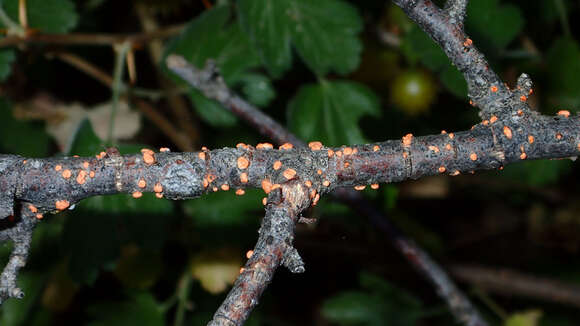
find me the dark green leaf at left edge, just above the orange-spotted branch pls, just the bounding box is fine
[0,98,51,157]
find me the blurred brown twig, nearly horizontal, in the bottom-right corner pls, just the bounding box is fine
[450,265,580,308]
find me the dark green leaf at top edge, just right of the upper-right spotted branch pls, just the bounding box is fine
[465,0,524,49]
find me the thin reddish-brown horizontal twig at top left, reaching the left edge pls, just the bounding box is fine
[0,24,185,48]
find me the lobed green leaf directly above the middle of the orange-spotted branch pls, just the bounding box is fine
[288,80,380,146]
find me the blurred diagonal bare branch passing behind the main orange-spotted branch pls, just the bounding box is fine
[167,56,494,326]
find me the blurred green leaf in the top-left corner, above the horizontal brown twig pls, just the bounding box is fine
[2,0,78,34]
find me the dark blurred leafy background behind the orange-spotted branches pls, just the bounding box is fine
[0,0,580,326]
